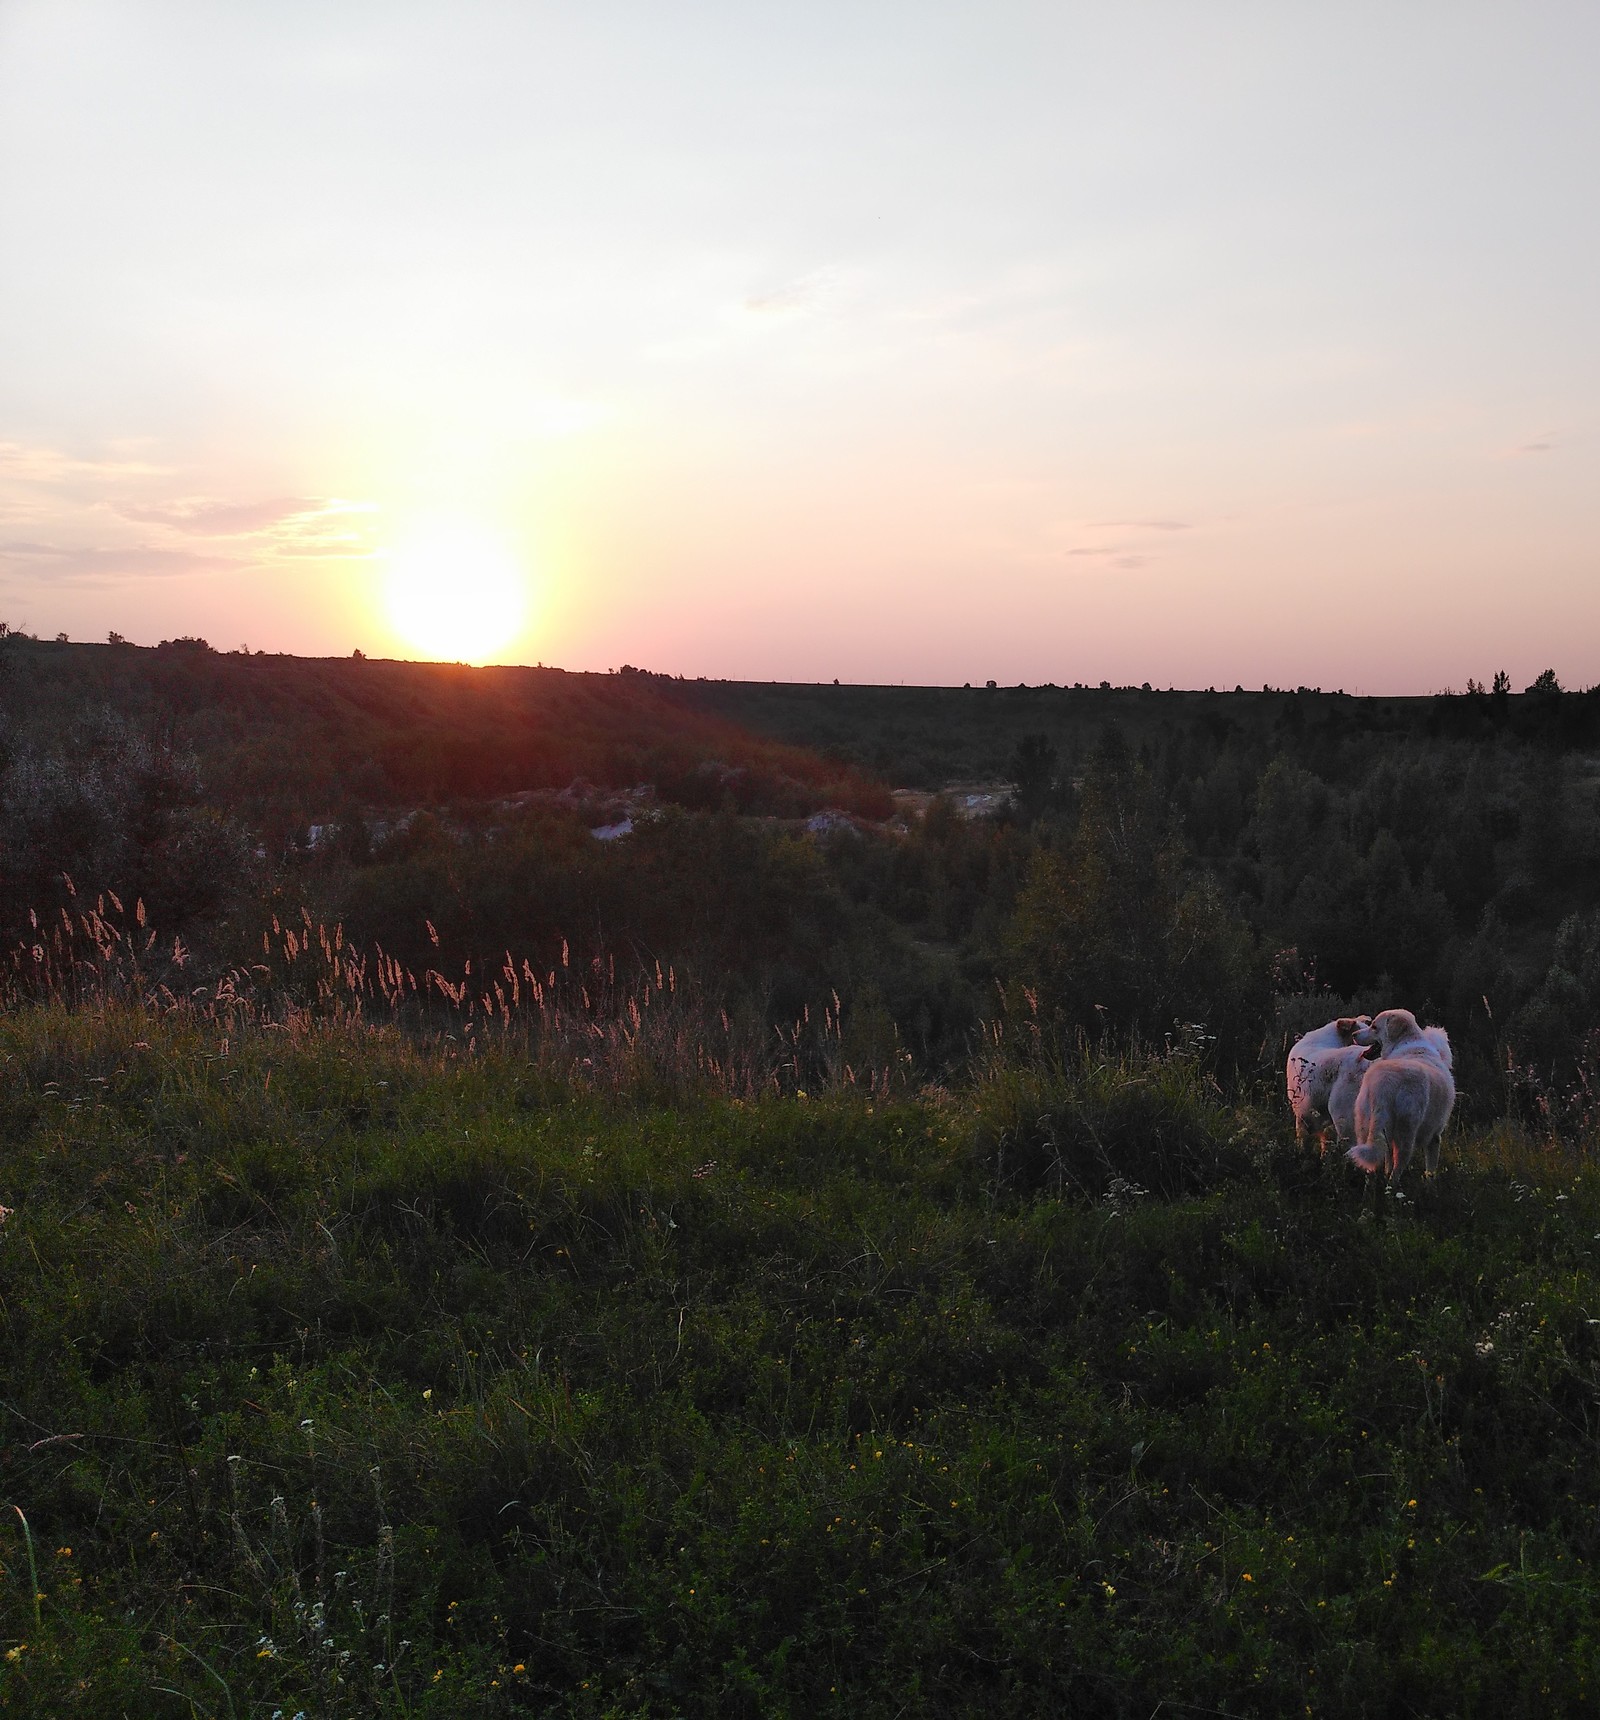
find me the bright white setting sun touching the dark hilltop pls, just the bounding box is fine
[384,523,528,664]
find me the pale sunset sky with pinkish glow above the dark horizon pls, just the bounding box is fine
[0,0,1600,693]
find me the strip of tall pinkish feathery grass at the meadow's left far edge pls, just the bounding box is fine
[0,881,912,1099]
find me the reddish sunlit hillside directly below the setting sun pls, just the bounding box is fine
[0,635,889,831]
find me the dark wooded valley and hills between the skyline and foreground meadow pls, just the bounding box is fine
[0,635,1600,1128]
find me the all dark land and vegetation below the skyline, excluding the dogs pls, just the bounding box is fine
[0,638,1600,1720]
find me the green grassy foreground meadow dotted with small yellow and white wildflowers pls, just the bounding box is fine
[0,1003,1600,1720]
